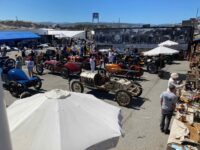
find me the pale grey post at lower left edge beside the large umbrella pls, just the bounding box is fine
[0,80,12,150]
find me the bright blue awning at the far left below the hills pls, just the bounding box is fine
[0,31,40,42]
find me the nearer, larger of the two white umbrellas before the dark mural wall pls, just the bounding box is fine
[144,46,179,56]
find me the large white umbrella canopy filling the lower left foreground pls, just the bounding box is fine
[7,90,121,150]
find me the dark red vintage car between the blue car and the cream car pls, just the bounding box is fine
[44,60,82,78]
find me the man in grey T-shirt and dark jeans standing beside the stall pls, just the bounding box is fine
[160,85,178,134]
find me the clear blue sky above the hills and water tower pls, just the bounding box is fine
[0,0,200,24]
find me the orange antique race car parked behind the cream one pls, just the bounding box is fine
[105,63,144,79]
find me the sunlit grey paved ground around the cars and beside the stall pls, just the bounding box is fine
[4,50,189,150]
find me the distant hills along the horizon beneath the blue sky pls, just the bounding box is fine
[0,20,180,30]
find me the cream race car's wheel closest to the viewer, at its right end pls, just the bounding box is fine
[115,90,132,107]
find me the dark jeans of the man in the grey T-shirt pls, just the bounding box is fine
[160,112,173,131]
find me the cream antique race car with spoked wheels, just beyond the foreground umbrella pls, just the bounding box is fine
[70,72,142,106]
